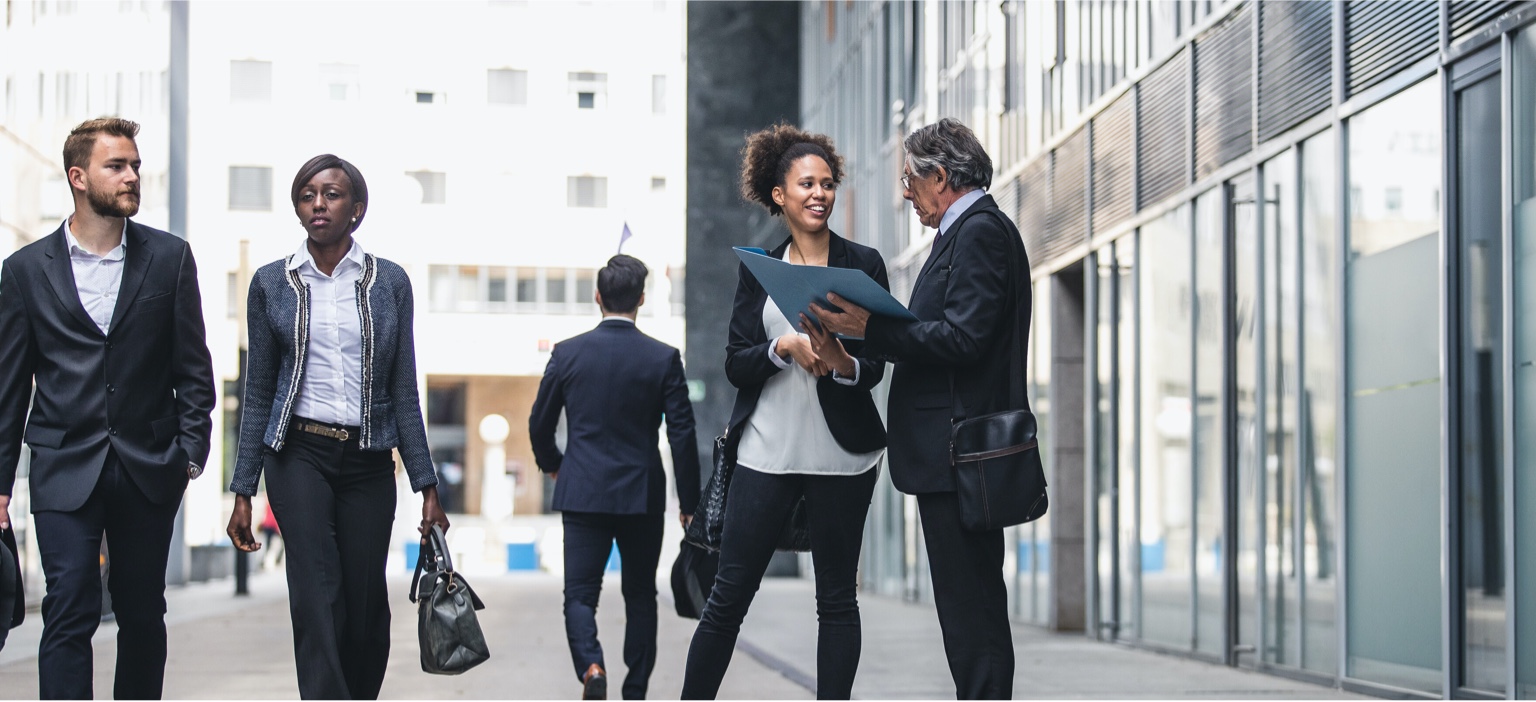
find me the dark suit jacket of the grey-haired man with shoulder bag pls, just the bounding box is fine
[865,195,1031,495]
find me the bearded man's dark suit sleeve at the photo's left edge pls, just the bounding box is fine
[0,261,37,496]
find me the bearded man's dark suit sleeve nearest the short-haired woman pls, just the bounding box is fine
[170,244,214,465]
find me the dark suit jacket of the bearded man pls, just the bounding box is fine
[0,221,214,512]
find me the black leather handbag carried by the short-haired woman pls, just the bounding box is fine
[410,525,490,676]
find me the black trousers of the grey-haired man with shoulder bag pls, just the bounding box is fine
[917,493,1014,699]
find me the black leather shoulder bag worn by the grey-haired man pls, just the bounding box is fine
[949,213,1051,531]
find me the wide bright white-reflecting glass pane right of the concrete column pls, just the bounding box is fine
[1138,206,1193,648]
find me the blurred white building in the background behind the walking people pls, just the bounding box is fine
[0,0,687,598]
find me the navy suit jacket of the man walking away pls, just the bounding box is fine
[528,320,699,515]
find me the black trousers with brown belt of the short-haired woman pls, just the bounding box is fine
[264,430,395,699]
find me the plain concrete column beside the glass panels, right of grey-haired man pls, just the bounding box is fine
[1046,267,1092,631]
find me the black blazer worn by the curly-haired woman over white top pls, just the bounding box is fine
[725,233,891,455]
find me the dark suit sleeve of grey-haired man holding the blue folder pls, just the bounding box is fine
[865,215,1014,366]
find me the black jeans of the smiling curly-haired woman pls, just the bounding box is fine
[682,467,877,699]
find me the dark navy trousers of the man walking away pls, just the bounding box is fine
[561,512,667,699]
